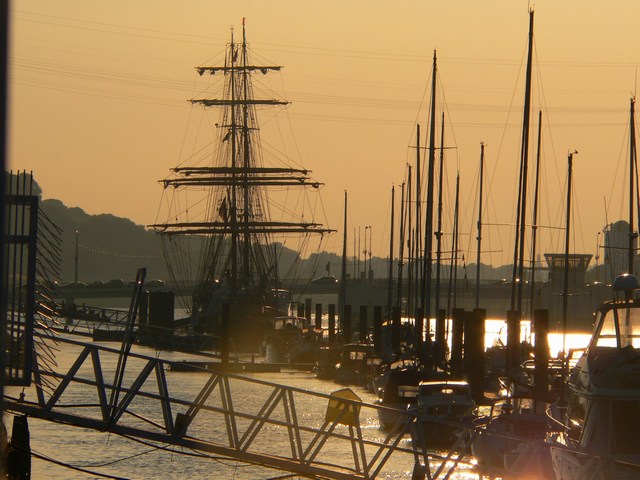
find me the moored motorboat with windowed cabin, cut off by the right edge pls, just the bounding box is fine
[550,274,640,480]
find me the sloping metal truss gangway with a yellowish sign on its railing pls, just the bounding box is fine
[4,337,478,479]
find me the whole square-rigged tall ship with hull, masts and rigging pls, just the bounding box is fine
[150,20,334,350]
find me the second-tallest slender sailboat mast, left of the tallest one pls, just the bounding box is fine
[420,50,437,332]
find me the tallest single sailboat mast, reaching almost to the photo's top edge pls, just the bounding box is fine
[511,10,533,315]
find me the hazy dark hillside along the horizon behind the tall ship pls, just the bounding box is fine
[9,175,544,283]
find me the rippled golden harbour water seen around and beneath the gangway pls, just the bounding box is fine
[7,320,589,480]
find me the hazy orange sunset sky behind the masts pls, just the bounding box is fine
[9,0,640,265]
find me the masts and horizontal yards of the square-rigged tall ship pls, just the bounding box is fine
[150,21,334,306]
